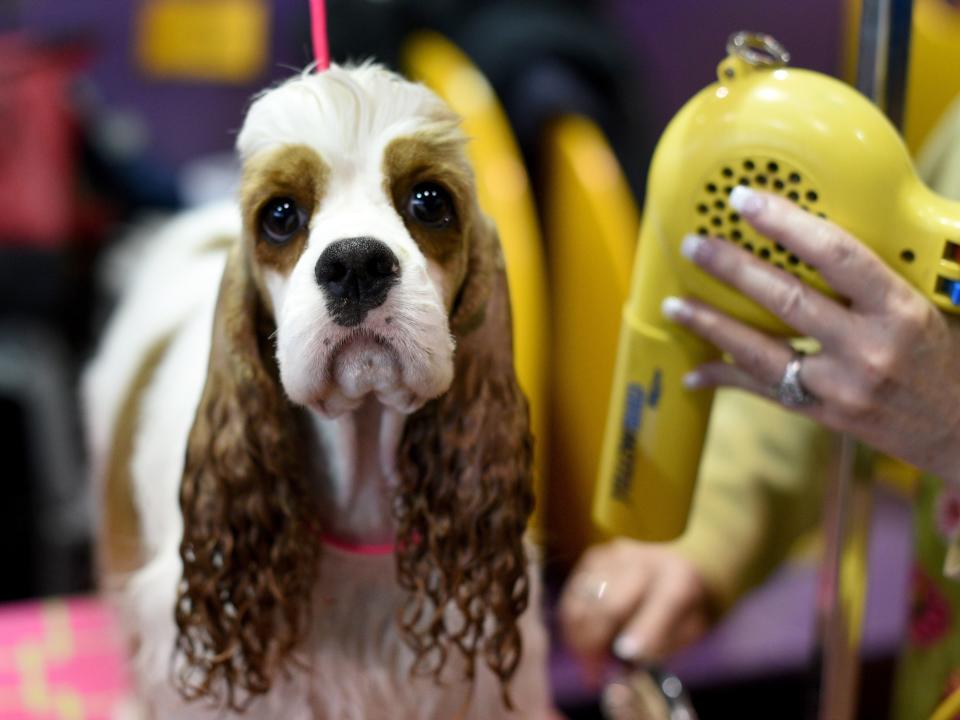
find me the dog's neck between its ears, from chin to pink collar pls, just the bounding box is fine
[310,395,405,547]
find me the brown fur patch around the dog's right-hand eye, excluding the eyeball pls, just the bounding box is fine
[383,132,477,302]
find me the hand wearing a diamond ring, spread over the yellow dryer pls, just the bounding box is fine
[663,187,960,481]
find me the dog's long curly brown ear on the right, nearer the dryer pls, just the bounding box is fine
[397,214,533,707]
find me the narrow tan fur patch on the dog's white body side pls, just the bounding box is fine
[97,338,170,578]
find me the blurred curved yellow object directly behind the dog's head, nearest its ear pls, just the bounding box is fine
[403,32,548,528]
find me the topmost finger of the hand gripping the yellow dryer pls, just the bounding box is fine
[730,185,911,308]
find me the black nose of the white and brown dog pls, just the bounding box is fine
[316,237,400,327]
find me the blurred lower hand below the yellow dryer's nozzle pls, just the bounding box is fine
[559,539,715,682]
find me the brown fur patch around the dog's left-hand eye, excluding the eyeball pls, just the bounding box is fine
[240,145,330,275]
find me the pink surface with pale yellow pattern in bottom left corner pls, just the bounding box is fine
[0,598,129,720]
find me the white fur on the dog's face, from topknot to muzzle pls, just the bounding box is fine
[244,65,458,416]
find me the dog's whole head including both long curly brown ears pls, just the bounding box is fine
[177,65,532,705]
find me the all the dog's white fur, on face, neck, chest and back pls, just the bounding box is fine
[83,65,550,720]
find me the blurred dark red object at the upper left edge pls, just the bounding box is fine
[0,35,87,249]
